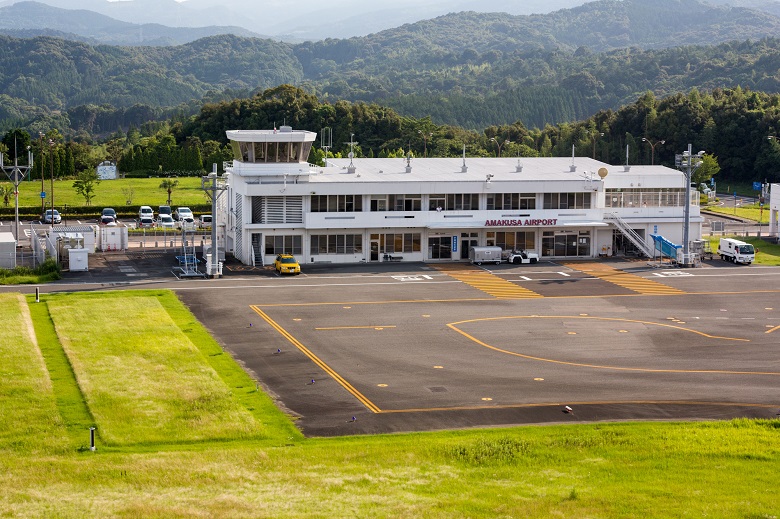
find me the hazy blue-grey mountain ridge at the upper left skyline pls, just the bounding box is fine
[0,1,263,46]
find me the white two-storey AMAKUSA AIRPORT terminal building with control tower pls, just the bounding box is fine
[217,127,702,265]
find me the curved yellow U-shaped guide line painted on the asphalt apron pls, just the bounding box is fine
[447,315,780,376]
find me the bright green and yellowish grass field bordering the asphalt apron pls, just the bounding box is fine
[0,290,780,518]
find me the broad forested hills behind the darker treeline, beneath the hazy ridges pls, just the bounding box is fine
[6,0,780,134]
